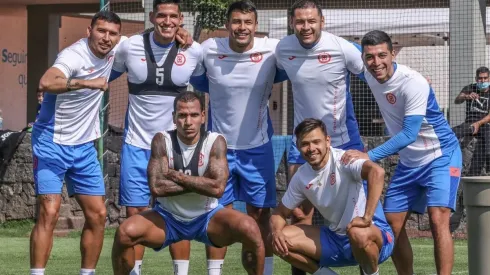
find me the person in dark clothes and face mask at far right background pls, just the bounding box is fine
[453,67,490,176]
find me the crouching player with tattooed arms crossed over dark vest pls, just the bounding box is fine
[112,92,264,275]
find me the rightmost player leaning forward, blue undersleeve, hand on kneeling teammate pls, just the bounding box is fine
[343,31,462,275]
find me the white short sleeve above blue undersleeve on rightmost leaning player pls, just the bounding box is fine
[402,76,431,116]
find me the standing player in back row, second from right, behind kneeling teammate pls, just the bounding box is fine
[276,0,364,237]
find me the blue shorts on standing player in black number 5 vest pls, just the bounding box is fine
[119,142,151,207]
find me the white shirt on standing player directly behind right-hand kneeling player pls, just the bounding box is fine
[276,31,364,147]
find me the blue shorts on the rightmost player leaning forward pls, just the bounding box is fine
[384,145,462,216]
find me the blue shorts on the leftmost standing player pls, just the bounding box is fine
[32,130,105,196]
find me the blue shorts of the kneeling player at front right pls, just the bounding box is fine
[320,215,395,267]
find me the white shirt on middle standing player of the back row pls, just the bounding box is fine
[202,37,279,150]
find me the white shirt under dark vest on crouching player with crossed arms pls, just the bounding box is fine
[157,132,220,222]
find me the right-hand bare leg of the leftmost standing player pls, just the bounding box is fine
[75,195,107,269]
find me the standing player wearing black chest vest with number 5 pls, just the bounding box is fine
[111,0,204,274]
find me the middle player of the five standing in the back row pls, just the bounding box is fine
[187,0,286,275]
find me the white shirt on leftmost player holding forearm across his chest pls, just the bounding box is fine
[34,37,126,145]
